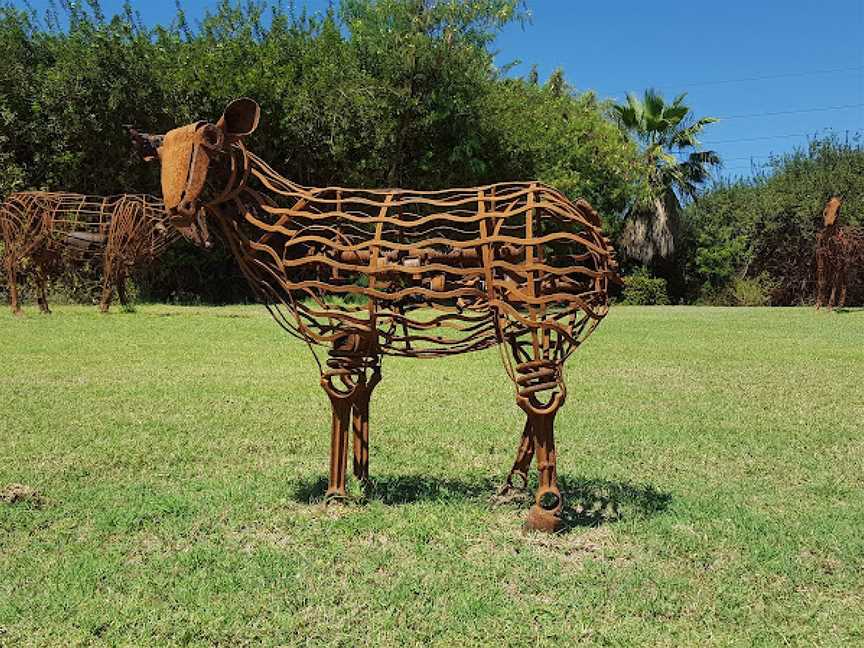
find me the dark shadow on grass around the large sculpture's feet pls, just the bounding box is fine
[293,475,672,533]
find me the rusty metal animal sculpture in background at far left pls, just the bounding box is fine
[0,191,178,314]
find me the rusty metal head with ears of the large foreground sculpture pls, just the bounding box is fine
[129,97,261,247]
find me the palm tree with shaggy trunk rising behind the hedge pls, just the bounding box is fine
[612,89,720,287]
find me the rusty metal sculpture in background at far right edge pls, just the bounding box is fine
[816,196,864,310]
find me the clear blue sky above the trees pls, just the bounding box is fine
[15,0,864,175]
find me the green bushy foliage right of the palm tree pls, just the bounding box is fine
[685,137,864,305]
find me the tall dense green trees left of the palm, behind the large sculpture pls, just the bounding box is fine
[0,0,639,301]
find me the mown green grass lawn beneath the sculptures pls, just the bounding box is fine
[0,306,864,647]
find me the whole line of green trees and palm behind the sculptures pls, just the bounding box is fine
[0,0,861,302]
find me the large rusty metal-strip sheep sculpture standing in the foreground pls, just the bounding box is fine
[131,99,617,530]
